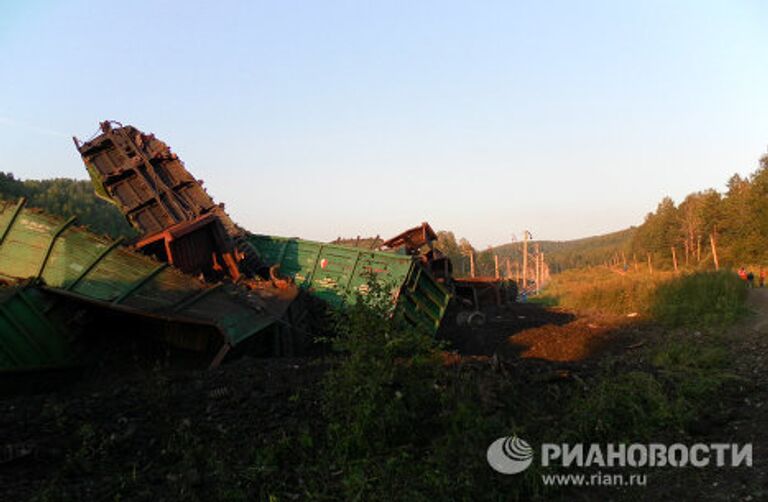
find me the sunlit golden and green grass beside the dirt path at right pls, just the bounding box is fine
[545,268,747,452]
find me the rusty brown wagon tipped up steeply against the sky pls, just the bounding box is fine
[73,121,259,280]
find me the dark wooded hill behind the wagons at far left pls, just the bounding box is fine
[0,172,135,237]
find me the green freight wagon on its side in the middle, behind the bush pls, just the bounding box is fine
[246,234,450,334]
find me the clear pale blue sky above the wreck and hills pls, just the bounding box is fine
[0,0,768,247]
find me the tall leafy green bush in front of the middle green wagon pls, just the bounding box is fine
[323,282,448,459]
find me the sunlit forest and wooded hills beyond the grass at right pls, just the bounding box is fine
[439,150,768,275]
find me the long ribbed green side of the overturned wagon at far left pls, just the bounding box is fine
[0,200,295,345]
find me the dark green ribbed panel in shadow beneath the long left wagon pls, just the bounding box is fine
[0,286,74,371]
